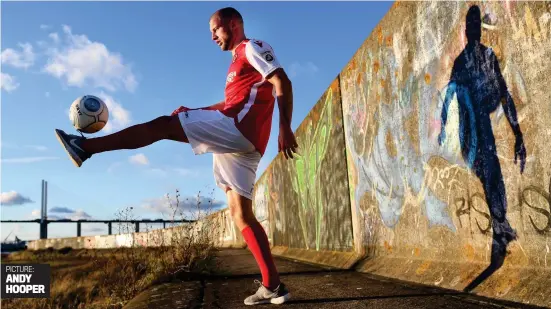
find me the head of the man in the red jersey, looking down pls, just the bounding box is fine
[209,7,245,51]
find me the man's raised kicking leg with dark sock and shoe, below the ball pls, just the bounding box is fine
[55,115,189,166]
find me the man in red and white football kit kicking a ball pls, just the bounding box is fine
[56,7,298,305]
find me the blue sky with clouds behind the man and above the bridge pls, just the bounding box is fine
[1,1,392,239]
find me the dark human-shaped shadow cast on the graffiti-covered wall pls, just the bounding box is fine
[438,5,526,292]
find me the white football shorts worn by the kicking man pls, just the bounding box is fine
[178,110,261,200]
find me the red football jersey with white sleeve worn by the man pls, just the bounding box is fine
[221,39,281,155]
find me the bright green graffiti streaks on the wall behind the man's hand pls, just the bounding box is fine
[290,88,333,250]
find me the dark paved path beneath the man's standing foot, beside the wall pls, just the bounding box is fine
[124,249,548,309]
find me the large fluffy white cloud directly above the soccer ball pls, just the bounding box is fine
[44,25,137,92]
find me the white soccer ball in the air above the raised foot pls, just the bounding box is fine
[69,95,109,133]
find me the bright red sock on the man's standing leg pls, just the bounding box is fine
[241,222,279,290]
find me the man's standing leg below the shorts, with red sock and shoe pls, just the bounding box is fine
[226,190,290,305]
